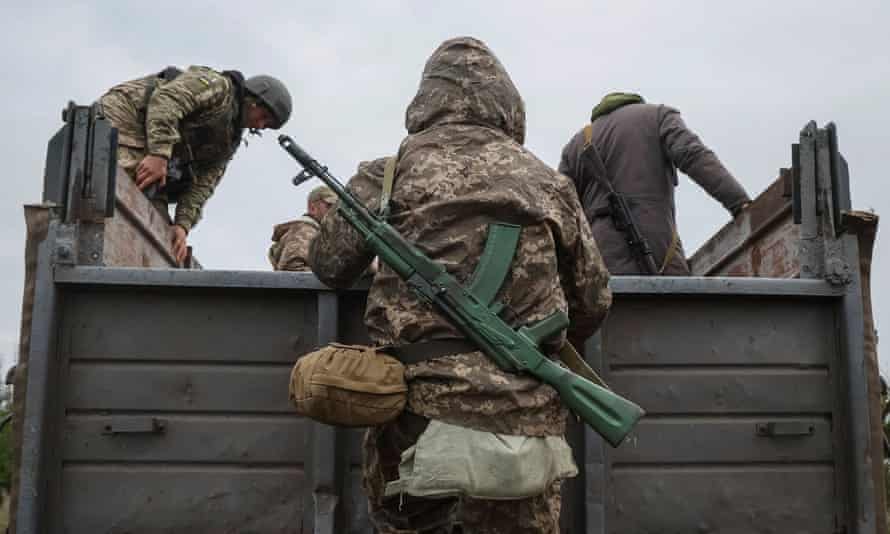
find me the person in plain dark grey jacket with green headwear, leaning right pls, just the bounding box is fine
[559,93,751,276]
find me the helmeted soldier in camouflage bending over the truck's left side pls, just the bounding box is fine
[99,67,292,263]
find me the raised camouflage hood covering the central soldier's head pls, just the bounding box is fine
[405,37,525,144]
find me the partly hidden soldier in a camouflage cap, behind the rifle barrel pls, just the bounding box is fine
[269,186,337,271]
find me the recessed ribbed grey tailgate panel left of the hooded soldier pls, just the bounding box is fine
[53,283,323,534]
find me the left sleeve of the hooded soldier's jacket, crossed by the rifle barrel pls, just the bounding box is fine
[309,158,386,288]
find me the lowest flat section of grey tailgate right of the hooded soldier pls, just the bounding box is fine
[608,465,839,534]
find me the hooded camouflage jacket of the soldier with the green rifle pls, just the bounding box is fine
[309,38,611,436]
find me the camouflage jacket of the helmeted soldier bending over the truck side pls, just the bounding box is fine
[100,67,243,230]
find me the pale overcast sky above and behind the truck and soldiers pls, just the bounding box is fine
[0,0,890,374]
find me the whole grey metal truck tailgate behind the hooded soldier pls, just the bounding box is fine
[22,267,845,534]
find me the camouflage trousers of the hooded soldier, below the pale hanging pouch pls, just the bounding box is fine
[363,412,561,534]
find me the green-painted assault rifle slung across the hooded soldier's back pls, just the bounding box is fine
[278,135,644,447]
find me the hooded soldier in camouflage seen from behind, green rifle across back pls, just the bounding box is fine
[309,37,611,534]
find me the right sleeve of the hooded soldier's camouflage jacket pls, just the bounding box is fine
[556,175,612,341]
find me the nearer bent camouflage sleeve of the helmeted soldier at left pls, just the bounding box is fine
[145,67,232,159]
